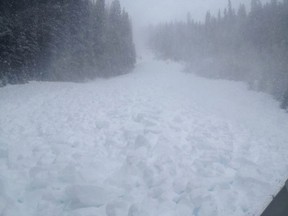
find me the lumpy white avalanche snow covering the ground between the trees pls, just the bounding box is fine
[0,54,288,216]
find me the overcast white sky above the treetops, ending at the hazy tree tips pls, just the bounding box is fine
[120,0,267,24]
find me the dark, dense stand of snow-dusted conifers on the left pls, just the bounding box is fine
[0,0,136,86]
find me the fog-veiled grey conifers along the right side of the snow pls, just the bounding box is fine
[149,0,288,108]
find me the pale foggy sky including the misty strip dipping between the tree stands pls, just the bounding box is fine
[116,0,269,51]
